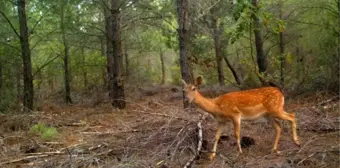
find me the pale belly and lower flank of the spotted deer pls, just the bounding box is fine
[239,104,266,120]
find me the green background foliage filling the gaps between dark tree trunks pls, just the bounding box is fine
[0,0,340,112]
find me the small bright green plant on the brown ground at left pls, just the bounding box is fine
[29,123,58,140]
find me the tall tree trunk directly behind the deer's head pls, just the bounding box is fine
[176,0,193,108]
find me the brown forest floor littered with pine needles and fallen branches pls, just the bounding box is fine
[0,87,340,168]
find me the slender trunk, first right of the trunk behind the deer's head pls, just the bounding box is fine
[212,16,224,86]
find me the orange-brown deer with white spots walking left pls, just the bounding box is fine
[182,76,300,160]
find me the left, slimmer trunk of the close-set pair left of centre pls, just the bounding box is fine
[103,1,114,99]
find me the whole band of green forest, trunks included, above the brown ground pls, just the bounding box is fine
[0,0,340,111]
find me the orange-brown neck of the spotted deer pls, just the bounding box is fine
[194,92,218,114]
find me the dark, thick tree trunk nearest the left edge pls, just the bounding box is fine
[18,0,34,111]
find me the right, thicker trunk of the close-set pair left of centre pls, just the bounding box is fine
[111,0,126,109]
